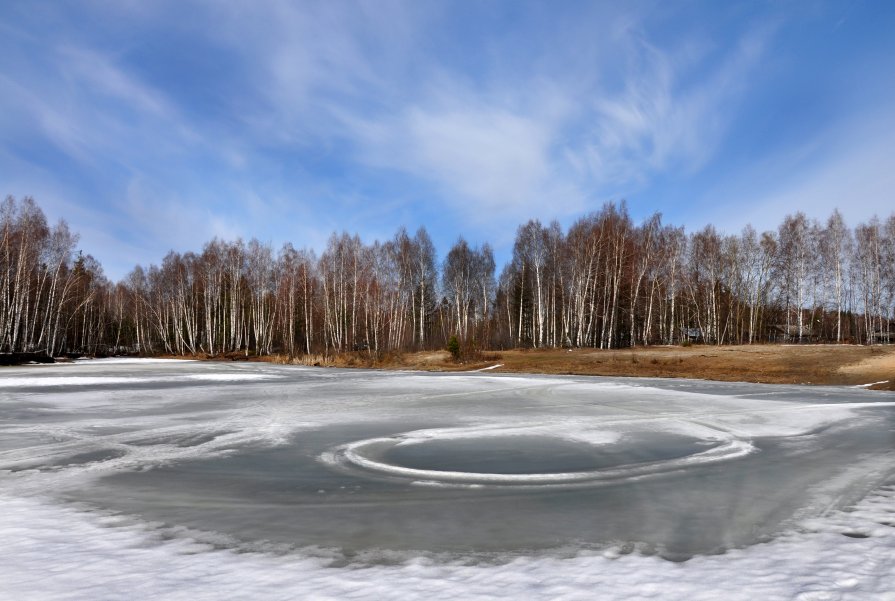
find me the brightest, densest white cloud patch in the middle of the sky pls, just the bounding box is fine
[342,86,576,221]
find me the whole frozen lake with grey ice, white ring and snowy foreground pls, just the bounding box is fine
[0,360,895,599]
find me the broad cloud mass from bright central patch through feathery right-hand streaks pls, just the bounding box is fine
[333,15,772,230]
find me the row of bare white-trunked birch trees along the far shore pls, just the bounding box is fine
[0,197,895,357]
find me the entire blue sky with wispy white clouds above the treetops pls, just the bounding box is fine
[0,0,895,280]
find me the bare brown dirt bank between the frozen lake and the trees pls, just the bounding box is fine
[390,345,895,390]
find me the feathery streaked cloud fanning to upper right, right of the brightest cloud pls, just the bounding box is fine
[580,27,771,188]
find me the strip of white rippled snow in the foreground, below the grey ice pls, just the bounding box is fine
[0,486,895,601]
